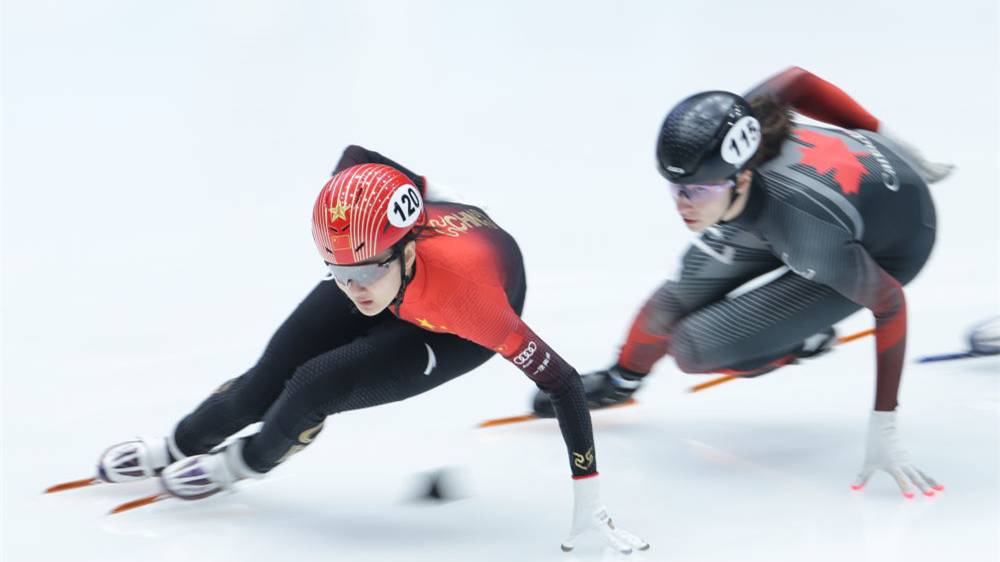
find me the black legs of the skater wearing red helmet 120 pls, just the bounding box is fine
[174,281,525,472]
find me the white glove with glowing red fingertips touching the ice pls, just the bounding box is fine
[851,411,944,499]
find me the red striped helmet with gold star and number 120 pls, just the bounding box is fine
[313,164,424,265]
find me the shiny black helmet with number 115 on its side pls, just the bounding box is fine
[656,91,761,183]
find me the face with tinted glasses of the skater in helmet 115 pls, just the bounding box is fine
[670,171,753,232]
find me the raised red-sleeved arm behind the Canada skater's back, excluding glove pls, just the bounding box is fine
[744,66,879,131]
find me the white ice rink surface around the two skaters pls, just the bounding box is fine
[0,0,1000,562]
